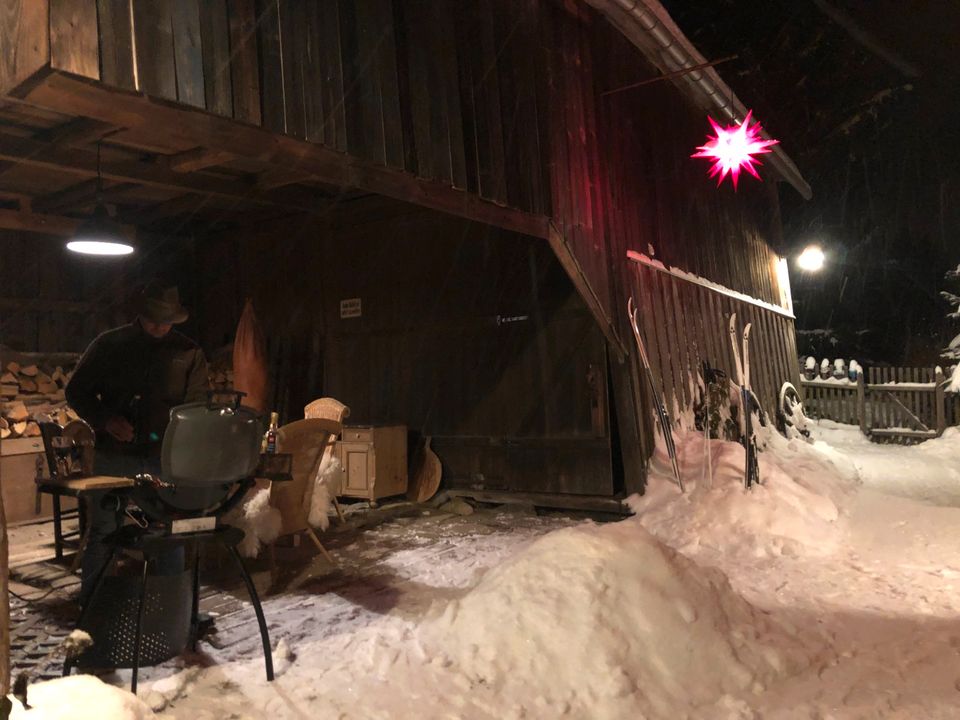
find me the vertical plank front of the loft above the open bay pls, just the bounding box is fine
[52,0,552,217]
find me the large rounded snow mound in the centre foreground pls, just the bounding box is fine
[420,518,815,718]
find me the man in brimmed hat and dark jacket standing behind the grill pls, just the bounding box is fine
[66,283,208,602]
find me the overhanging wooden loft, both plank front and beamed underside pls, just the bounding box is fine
[0,0,623,357]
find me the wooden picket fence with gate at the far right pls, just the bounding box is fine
[800,367,960,443]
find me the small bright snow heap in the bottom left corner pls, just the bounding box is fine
[10,675,156,720]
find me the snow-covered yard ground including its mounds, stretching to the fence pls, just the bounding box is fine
[15,422,960,720]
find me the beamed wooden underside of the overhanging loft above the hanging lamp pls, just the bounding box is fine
[0,69,549,238]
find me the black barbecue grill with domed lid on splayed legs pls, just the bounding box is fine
[54,391,291,693]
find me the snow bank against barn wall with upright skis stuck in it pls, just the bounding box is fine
[629,428,859,557]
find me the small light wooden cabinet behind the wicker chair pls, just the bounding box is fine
[337,425,407,503]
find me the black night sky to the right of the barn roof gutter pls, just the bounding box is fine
[664,0,960,366]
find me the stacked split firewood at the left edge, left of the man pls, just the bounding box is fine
[0,361,77,440]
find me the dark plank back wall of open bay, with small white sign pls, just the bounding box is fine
[197,212,614,494]
